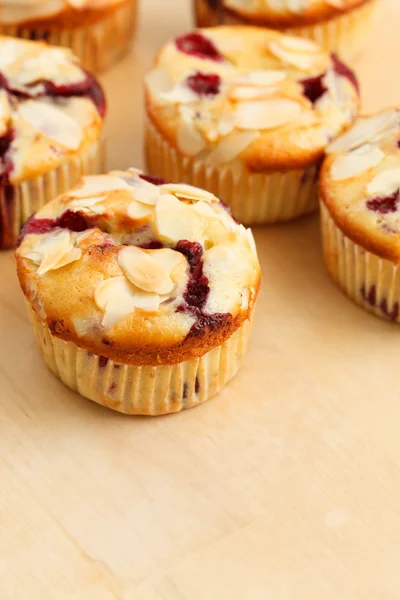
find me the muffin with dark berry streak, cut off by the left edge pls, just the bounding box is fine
[0,36,105,248]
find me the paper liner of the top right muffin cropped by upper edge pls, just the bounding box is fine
[194,0,377,59]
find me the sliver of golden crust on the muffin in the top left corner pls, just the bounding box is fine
[0,0,133,29]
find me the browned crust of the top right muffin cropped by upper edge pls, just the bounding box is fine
[223,0,373,29]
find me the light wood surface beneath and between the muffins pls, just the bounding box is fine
[0,0,400,600]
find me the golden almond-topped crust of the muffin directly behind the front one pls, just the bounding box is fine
[145,26,359,172]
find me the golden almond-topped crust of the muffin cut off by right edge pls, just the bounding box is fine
[319,107,400,264]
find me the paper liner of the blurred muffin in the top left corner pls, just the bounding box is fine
[0,0,137,73]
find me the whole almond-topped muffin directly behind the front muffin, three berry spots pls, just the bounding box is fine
[146,26,359,224]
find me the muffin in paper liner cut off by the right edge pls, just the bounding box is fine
[320,108,400,323]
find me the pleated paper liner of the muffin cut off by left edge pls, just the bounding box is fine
[0,140,104,249]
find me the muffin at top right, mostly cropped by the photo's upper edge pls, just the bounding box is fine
[194,0,377,58]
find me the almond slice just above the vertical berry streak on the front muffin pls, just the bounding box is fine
[155,194,196,242]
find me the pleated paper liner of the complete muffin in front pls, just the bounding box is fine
[28,304,251,415]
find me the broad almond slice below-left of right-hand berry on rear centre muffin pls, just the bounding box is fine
[236,98,302,130]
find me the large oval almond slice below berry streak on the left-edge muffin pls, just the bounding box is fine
[18,100,83,150]
